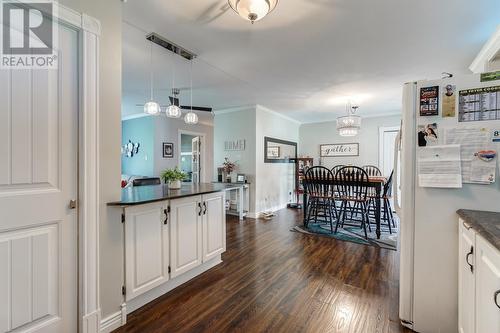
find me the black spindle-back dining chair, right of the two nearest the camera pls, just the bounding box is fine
[335,166,370,239]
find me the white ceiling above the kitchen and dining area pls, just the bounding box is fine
[123,0,500,122]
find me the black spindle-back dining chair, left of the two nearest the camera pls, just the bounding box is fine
[304,166,337,232]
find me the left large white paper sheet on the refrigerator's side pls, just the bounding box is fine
[417,145,462,188]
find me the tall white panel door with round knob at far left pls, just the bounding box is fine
[0,26,78,332]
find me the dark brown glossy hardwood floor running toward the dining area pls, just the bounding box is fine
[115,210,410,333]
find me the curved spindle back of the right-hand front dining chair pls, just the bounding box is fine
[335,166,369,201]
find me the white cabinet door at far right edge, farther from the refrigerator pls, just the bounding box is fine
[475,235,500,333]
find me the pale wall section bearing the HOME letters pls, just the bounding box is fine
[214,107,256,211]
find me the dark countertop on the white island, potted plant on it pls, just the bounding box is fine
[108,183,243,206]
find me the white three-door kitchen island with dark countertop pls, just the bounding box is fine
[108,184,226,322]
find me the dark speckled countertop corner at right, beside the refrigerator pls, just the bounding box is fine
[457,209,500,251]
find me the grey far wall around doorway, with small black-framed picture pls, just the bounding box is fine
[154,116,214,183]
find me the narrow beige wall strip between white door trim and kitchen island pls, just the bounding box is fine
[59,0,123,318]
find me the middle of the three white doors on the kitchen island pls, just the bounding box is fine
[170,196,202,278]
